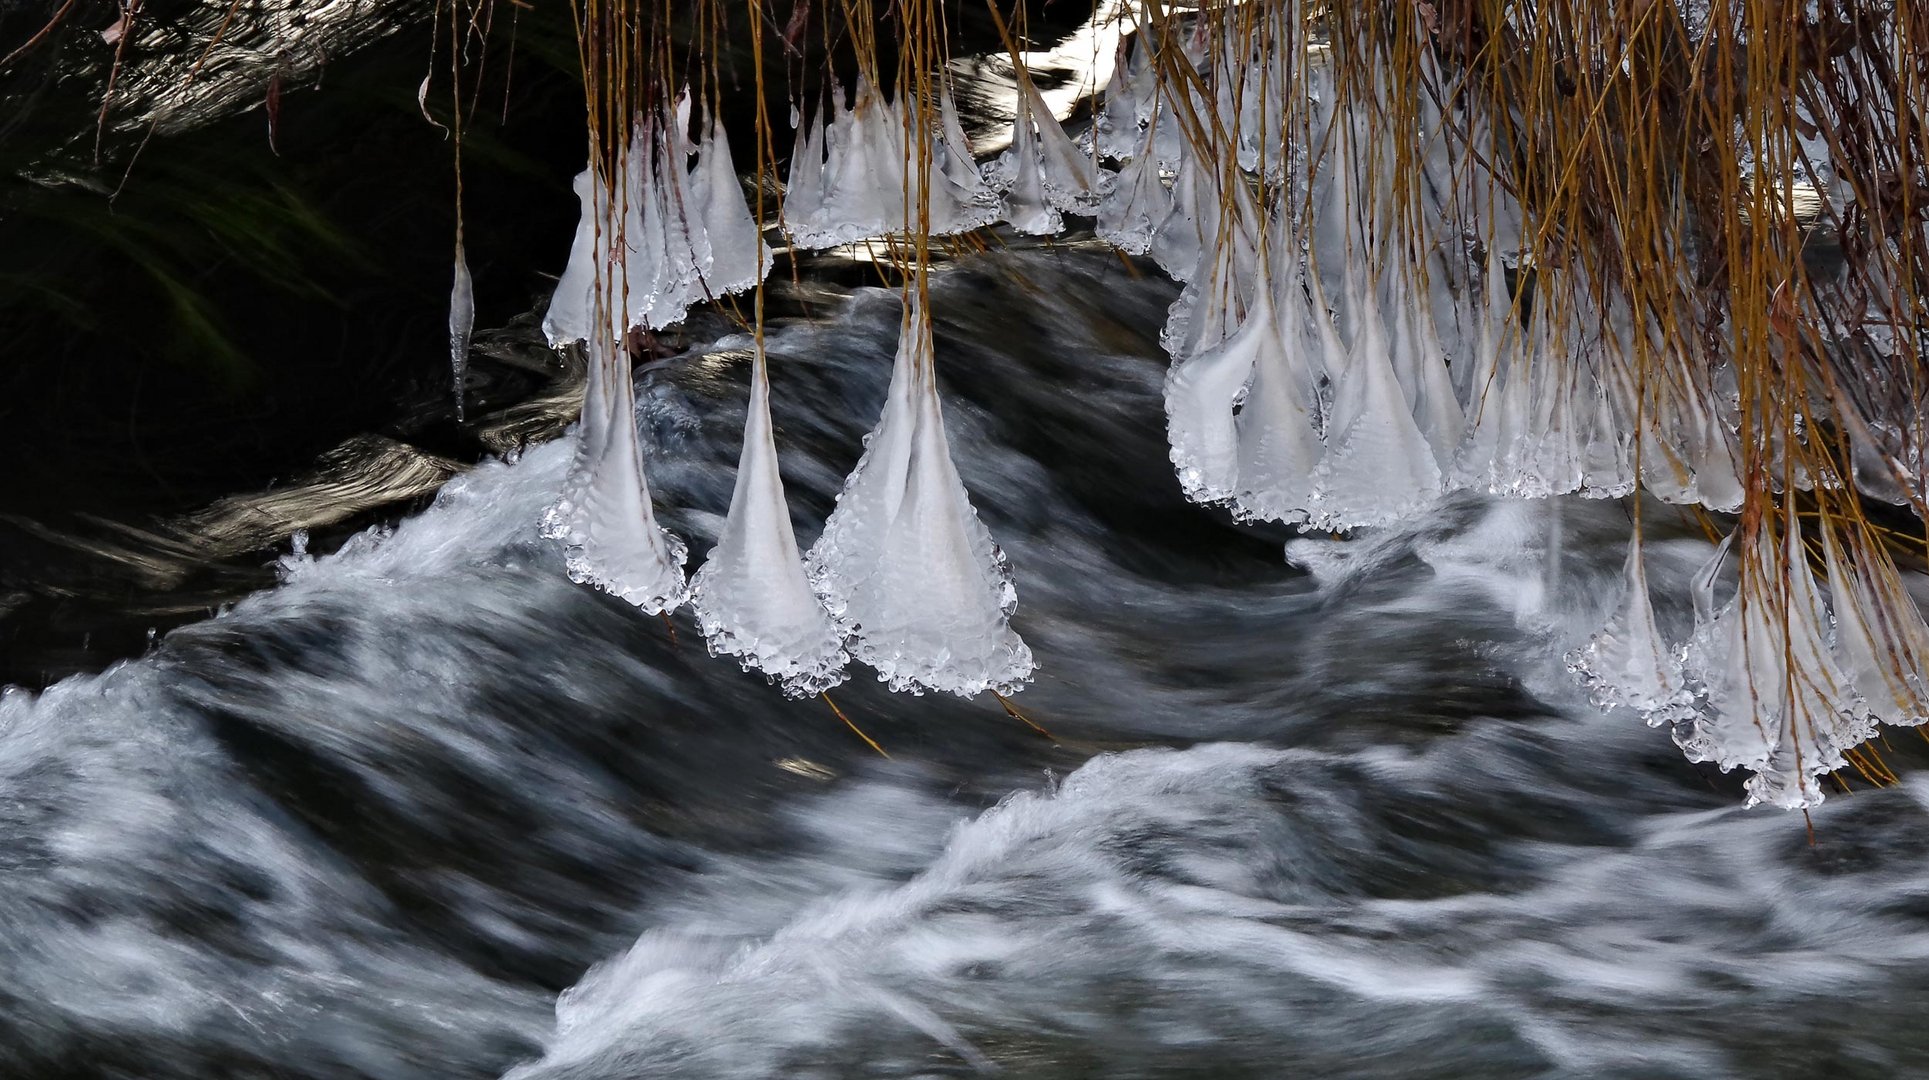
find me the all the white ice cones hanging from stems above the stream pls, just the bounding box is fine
[546,31,1929,806]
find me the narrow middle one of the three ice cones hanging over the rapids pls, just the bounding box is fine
[691,349,847,698]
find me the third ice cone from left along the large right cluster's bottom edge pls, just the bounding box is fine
[1314,271,1441,528]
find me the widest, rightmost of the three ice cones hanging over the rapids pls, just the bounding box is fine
[806,295,1032,696]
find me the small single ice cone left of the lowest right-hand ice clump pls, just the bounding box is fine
[1568,528,1694,727]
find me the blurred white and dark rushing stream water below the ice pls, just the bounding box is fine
[0,247,1929,1080]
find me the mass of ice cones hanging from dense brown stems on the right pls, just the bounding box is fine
[1086,23,1929,808]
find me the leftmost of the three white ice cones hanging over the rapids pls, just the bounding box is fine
[542,329,685,615]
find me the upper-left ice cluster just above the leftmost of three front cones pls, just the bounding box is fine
[542,96,770,345]
